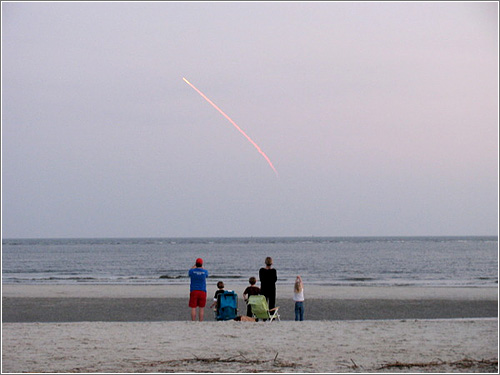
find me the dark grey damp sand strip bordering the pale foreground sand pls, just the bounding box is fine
[2,297,498,323]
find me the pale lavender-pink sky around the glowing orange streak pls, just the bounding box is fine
[2,2,499,238]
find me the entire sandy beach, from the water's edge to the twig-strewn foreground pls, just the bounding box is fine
[2,285,498,373]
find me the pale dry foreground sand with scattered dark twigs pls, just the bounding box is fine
[2,319,498,373]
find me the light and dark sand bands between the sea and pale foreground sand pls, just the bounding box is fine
[2,285,498,323]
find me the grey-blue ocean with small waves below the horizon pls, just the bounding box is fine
[2,236,498,288]
